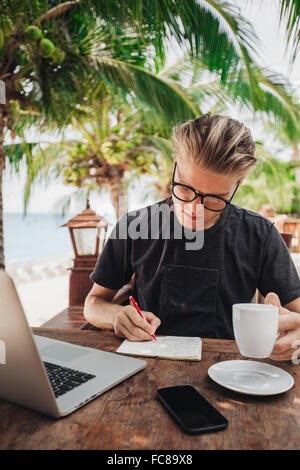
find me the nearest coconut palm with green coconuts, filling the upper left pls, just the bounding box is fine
[0,0,268,268]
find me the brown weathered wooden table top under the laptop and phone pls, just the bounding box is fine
[0,328,300,451]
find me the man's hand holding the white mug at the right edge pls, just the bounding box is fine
[265,292,300,361]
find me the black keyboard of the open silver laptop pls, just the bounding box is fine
[44,362,96,397]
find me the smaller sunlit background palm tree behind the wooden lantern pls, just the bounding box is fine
[17,95,165,218]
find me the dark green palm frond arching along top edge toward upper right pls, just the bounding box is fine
[89,0,259,80]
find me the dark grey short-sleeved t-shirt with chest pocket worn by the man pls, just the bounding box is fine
[90,197,300,339]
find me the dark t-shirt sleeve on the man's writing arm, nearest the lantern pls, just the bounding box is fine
[90,216,133,289]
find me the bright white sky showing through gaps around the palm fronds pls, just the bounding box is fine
[3,0,300,215]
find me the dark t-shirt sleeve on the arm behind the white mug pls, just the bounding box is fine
[257,224,300,305]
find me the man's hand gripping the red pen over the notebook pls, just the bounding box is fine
[114,305,161,341]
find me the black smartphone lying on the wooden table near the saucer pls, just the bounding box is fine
[157,385,228,434]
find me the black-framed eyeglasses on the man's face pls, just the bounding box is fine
[172,162,240,212]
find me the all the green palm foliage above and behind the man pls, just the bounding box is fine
[0,0,299,218]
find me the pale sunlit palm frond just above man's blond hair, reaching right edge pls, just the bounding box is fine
[159,56,300,140]
